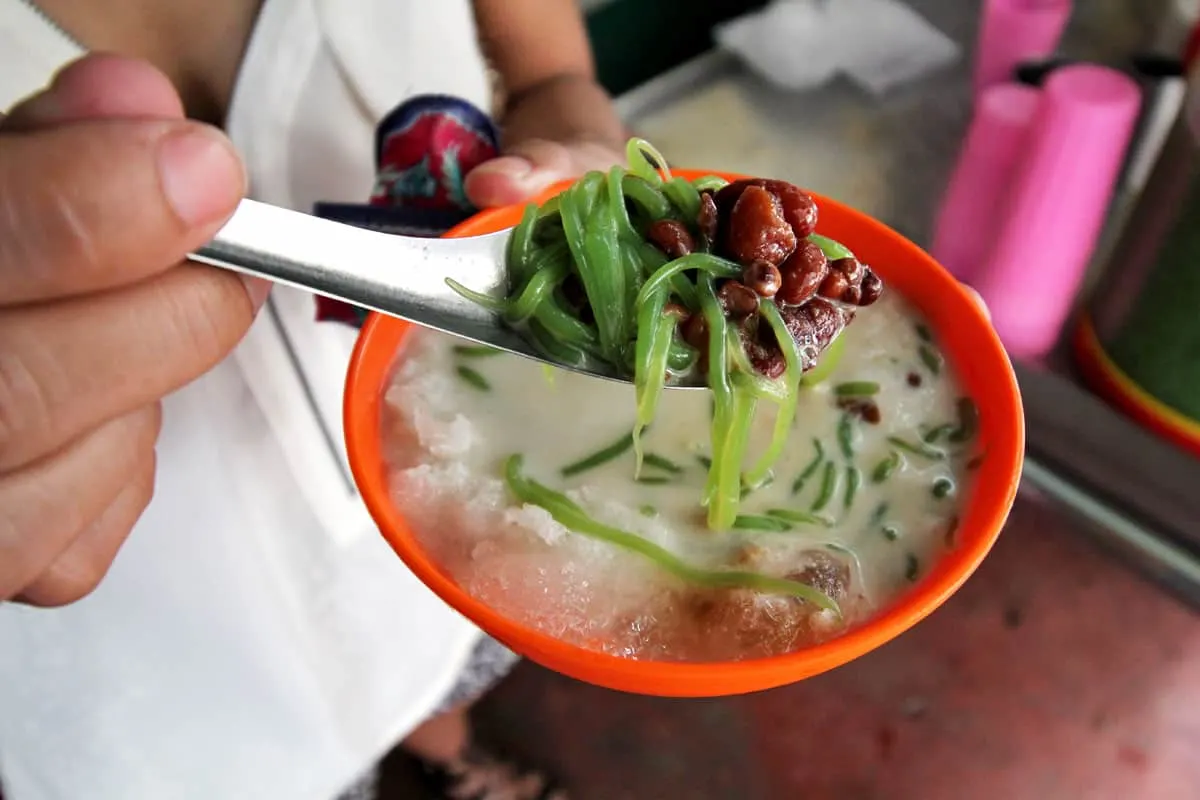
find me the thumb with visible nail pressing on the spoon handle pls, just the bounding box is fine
[0,120,245,306]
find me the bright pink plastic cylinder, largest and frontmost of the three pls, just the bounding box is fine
[974,65,1141,359]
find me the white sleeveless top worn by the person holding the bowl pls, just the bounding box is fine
[0,0,490,800]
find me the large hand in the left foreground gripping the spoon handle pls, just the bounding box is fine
[0,56,266,606]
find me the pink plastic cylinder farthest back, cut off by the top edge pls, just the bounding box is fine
[974,0,1072,98]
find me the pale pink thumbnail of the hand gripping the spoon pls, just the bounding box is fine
[158,126,245,225]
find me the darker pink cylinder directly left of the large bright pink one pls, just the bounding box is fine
[930,83,1042,283]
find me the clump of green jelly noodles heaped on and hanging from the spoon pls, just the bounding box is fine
[451,138,854,531]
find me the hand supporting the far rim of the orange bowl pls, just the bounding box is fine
[466,139,624,209]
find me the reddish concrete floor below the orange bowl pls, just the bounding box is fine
[384,500,1200,800]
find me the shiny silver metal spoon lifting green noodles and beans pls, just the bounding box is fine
[191,200,703,389]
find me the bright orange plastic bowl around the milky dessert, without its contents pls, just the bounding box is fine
[344,170,1025,697]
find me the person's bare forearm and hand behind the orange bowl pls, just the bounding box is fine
[467,0,625,206]
